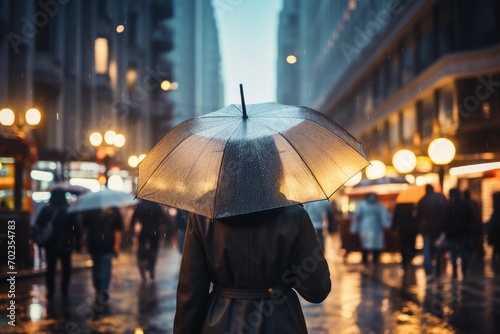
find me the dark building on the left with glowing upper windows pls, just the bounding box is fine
[0,0,173,171]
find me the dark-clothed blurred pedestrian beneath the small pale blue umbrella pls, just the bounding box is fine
[82,207,123,302]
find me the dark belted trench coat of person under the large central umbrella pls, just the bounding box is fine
[174,205,331,334]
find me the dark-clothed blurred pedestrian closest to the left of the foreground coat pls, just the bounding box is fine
[131,200,168,283]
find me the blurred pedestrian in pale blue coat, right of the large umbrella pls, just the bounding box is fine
[351,193,391,264]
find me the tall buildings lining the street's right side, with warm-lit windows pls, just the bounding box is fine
[278,0,500,217]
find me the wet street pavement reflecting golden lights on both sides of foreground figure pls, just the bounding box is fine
[0,236,500,334]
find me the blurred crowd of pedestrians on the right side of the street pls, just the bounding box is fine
[348,184,500,281]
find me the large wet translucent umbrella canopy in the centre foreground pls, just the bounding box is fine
[137,103,369,218]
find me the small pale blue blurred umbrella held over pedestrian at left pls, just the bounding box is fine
[68,188,137,212]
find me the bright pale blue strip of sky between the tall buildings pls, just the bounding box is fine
[213,0,282,105]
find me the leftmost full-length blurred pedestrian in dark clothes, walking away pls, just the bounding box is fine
[35,188,79,301]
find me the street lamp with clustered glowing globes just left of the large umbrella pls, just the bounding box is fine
[89,130,125,187]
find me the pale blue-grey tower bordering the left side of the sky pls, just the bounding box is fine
[169,0,224,126]
